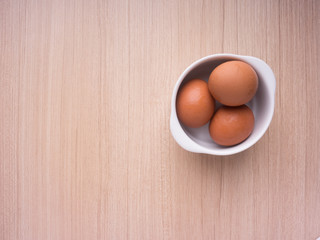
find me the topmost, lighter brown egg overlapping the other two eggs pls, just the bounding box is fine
[208,61,258,106]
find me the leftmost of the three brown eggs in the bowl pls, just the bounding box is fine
[176,79,215,128]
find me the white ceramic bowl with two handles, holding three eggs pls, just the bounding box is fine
[170,54,276,155]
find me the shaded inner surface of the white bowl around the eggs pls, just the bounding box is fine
[179,57,273,150]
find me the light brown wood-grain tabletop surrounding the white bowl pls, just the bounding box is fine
[0,0,320,240]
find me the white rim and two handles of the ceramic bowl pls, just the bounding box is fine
[170,53,276,156]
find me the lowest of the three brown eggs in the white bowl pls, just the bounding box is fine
[209,105,254,146]
